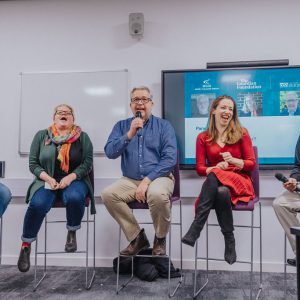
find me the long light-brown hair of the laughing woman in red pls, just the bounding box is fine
[207,95,243,145]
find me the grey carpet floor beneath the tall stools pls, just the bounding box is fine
[0,266,297,300]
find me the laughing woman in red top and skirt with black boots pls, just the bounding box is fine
[182,95,256,264]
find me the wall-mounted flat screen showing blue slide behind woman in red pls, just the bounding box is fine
[162,66,300,169]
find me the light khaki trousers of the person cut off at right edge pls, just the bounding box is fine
[273,191,300,254]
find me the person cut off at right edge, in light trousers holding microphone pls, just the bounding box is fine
[273,136,300,266]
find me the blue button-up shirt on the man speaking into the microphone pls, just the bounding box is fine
[104,115,177,180]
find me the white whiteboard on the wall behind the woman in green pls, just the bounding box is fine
[19,70,129,155]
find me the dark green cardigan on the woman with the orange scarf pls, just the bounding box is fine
[26,129,96,214]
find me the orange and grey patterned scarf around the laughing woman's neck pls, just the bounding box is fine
[48,124,81,173]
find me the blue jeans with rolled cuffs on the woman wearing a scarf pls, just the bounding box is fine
[22,180,88,243]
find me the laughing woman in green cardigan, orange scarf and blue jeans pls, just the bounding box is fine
[18,104,96,272]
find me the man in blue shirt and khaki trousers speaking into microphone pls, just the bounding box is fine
[101,86,177,256]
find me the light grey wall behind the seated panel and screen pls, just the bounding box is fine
[0,0,300,270]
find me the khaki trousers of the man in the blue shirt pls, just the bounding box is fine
[101,175,174,242]
